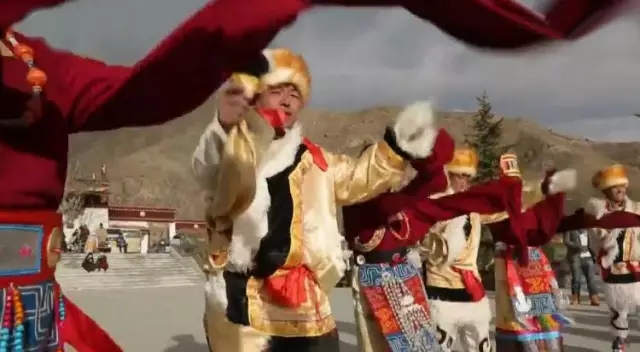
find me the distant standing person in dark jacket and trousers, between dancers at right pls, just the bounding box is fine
[564,229,600,306]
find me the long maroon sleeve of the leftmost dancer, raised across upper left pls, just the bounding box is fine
[21,0,308,132]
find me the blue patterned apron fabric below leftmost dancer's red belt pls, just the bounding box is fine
[0,281,58,352]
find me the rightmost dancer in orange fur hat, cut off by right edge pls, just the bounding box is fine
[587,164,640,352]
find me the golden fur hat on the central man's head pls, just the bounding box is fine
[231,48,311,103]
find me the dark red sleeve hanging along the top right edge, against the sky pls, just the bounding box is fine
[314,0,632,49]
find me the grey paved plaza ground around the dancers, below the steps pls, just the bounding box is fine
[63,286,640,352]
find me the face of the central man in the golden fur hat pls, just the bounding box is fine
[256,83,304,129]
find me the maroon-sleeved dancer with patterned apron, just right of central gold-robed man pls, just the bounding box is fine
[343,134,544,352]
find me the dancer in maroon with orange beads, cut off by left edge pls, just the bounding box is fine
[0,0,312,352]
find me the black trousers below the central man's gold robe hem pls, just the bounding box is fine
[267,330,340,352]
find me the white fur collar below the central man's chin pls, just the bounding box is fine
[258,123,302,178]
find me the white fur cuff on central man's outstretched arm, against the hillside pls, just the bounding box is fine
[393,101,438,158]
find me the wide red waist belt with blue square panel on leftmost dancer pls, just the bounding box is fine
[0,209,64,289]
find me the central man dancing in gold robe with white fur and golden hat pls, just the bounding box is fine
[193,49,436,352]
